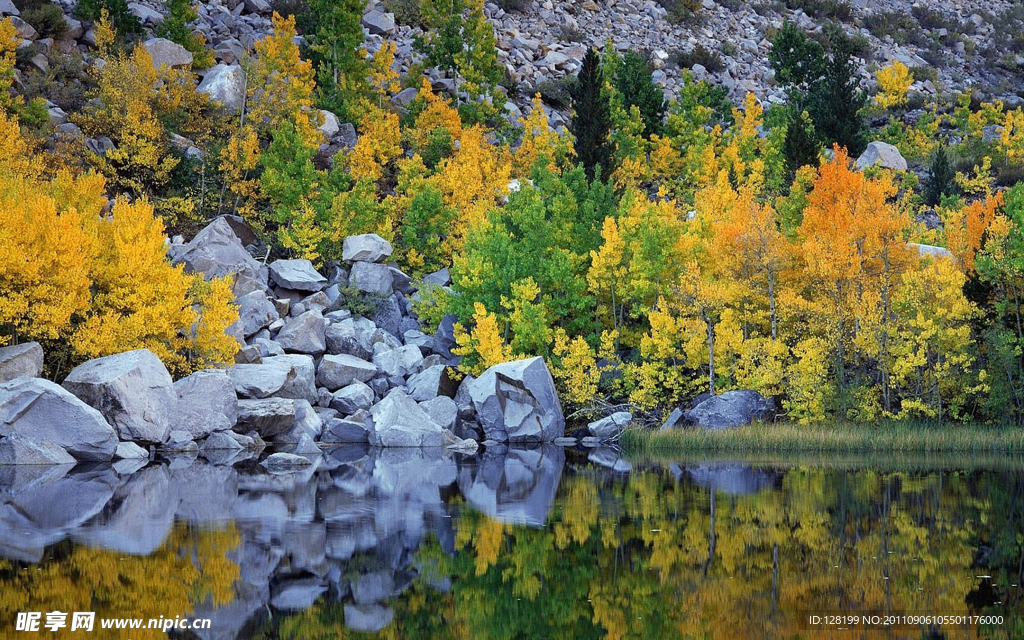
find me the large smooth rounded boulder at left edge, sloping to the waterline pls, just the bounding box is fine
[0,378,118,461]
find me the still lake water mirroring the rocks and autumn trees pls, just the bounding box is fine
[0,446,1024,640]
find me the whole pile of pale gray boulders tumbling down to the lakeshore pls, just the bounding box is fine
[0,217,565,460]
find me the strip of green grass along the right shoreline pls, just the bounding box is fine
[621,423,1024,456]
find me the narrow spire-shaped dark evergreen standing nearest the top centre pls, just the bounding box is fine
[569,48,611,180]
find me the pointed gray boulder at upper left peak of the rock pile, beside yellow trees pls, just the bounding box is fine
[170,216,266,296]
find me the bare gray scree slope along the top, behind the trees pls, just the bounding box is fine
[0,0,1024,130]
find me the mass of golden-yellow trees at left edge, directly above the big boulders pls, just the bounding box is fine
[0,116,238,374]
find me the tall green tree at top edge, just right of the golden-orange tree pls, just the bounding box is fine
[309,0,370,120]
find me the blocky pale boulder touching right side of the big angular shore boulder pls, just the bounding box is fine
[174,369,239,440]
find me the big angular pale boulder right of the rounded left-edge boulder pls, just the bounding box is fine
[63,349,178,443]
